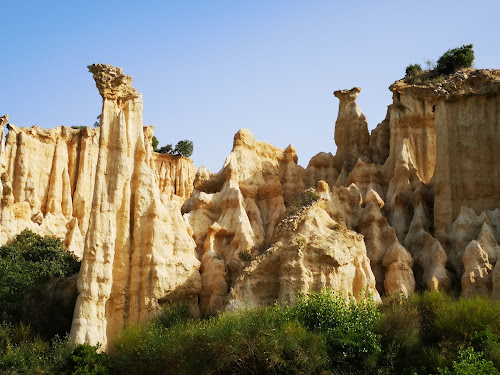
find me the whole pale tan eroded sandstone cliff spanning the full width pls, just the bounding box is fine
[0,64,500,347]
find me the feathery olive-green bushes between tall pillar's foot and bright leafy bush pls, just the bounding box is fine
[110,306,327,374]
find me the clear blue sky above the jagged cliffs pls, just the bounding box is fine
[0,0,500,172]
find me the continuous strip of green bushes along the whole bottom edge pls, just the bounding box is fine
[0,290,500,375]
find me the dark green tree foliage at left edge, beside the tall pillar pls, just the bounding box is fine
[0,230,80,322]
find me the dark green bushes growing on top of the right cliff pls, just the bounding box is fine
[405,44,474,85]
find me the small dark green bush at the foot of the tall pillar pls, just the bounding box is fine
[63,344,110,375]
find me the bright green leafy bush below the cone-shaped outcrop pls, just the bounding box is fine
[292,290,381,374]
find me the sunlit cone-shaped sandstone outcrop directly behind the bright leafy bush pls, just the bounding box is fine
[230,201,380,308]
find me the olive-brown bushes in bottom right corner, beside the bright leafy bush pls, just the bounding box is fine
[377,292,500,374]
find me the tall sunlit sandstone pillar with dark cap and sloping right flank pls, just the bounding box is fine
[67,64,200,347]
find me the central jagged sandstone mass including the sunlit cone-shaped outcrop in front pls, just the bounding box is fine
[183,129,379,312]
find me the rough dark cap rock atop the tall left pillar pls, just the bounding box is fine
[88,64,140,99]
